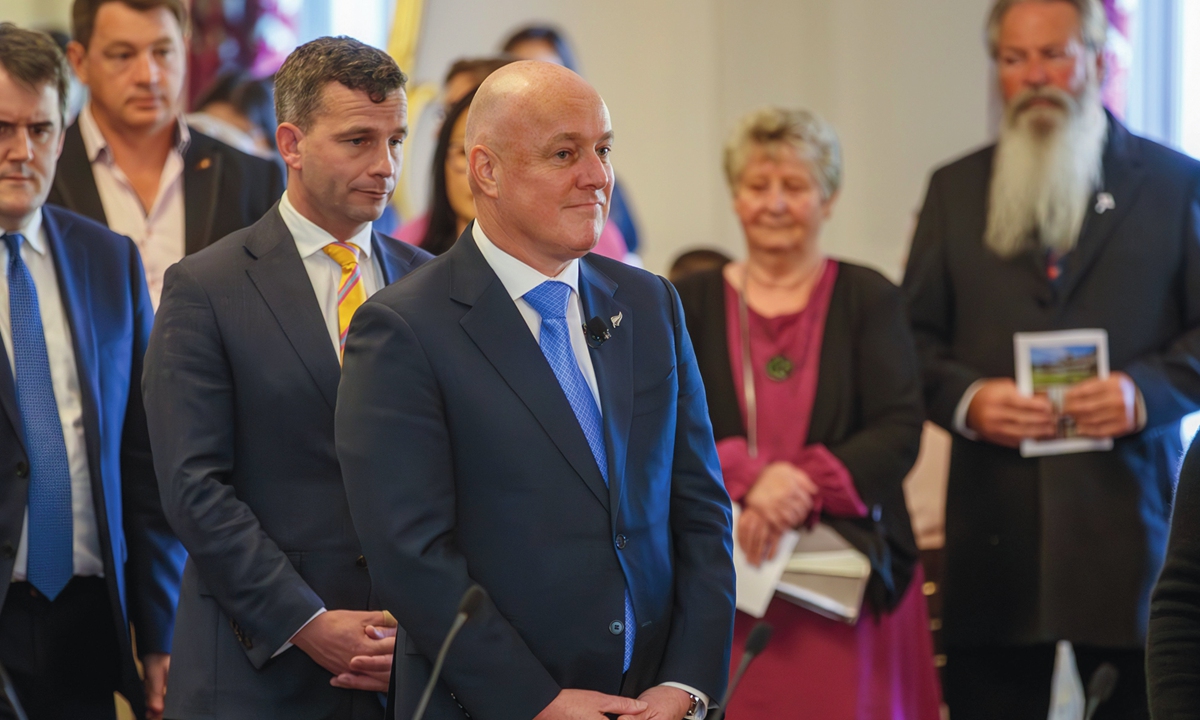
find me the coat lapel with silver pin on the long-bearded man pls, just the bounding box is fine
[1062,118,1146,302]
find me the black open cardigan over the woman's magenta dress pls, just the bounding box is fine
[678,263,924,612]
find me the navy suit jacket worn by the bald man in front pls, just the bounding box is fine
[336,228,733,720]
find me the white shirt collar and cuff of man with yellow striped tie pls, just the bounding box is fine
[271,192,384,658]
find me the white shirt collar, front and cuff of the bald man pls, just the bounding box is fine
[470,221,708,718]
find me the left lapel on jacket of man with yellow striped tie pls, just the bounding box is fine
[246,205,342,409]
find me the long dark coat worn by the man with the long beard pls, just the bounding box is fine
[904,119,1200,647]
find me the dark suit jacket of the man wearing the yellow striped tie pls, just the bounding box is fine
[144,206,431,720]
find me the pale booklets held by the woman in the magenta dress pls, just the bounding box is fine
[733,503,871,624]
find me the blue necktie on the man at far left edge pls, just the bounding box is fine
[4,234,74,600]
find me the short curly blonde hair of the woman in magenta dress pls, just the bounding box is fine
[725,107,841,199]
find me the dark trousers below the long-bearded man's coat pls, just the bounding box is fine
[942,644,1150,720]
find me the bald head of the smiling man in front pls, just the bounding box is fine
[466,61,613,276]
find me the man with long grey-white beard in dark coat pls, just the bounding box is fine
[904,0,1200,720]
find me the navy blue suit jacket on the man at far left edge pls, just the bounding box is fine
[0,205,185,712]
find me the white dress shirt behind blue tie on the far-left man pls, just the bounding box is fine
[0,211,103,581]
